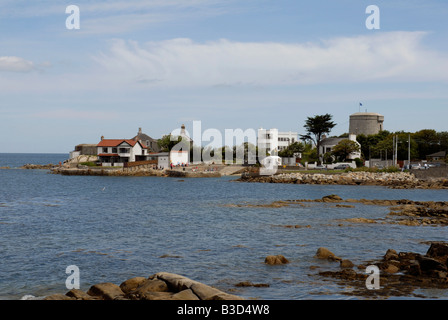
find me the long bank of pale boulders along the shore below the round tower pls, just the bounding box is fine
[237,171,448,189]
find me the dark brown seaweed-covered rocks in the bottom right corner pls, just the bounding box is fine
[316,242,448,298]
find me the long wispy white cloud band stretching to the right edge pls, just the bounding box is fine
[94,32,448,87]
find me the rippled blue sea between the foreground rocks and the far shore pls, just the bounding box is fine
[0,154,448,300]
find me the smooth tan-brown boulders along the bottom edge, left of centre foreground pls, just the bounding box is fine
[44,272,244,300]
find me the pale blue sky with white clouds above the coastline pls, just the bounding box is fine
[0,0,448,153]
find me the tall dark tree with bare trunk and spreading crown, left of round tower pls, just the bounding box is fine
[300,113,336,162]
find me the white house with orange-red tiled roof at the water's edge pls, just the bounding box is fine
[97,137,148,167]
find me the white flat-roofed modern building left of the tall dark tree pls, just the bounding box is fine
[257,128,298,156]
